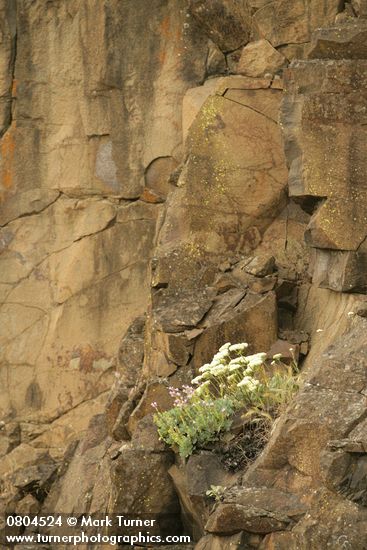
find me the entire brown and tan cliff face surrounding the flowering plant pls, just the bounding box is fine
[0,0,367,550]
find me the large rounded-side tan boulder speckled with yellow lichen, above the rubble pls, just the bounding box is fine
[157,80,287,260]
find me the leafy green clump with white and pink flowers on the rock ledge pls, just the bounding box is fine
[152,343,298,458]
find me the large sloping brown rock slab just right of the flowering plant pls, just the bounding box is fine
[245,318,367,485]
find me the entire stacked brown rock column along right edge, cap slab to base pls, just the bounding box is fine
[282,22,367,292]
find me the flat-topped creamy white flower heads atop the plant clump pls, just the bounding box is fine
[191,342,267,393]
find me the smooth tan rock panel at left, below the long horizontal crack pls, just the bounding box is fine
[0,201,159,416]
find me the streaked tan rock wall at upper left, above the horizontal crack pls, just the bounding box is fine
[0,0,207,203]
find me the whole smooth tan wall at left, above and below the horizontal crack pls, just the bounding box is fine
[0,0,208,421]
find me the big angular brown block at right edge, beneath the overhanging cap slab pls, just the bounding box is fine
[282,56,366,250]
